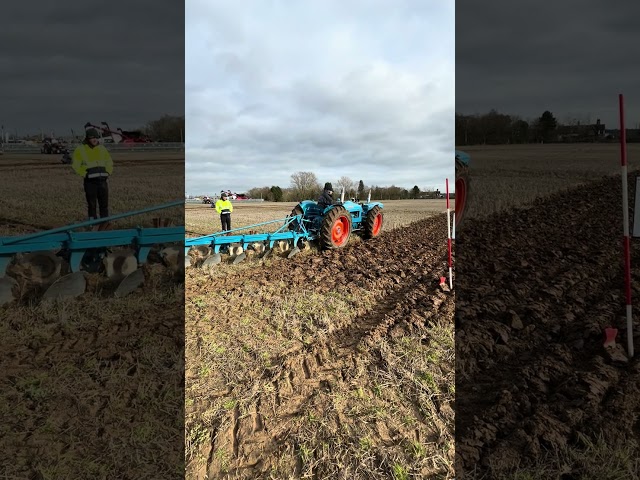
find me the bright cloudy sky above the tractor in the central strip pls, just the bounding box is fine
[185,0,455,194]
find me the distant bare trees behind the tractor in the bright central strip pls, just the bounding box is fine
[242,172,441,202]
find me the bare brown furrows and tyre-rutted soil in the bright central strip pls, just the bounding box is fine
[187,215,454,478]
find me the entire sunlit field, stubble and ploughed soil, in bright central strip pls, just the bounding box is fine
[185,200,455,479]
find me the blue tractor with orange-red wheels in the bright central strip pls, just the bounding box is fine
[289,191,384,250]
